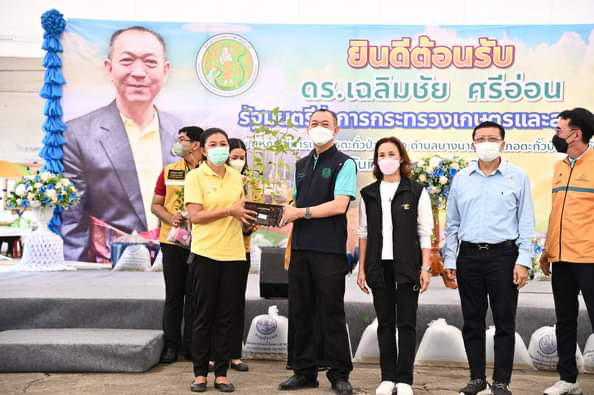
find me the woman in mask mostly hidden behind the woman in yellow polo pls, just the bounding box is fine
[222,138,254,372]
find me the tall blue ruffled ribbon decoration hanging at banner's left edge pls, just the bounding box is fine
[39,9,66,235]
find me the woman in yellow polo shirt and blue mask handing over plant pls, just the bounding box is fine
[185,128,255,392]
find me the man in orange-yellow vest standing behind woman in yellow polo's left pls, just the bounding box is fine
[151,126,204,363]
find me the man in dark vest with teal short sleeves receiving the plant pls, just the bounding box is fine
[279,110,357,395]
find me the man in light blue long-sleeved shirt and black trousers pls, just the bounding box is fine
[444,122,534,395]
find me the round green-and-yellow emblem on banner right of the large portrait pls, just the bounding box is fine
[196,33,258,96]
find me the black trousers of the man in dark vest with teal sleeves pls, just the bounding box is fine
[289,250,353,383]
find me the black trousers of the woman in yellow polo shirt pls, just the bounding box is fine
[191,254,245,377]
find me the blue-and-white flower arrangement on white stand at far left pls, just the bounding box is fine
[7,172,80,271]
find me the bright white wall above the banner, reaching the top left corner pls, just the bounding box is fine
[0,0,594,57]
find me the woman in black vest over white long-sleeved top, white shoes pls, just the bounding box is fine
[357,137,433,395]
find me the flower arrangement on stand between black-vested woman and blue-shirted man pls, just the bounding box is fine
[411,155,467,288]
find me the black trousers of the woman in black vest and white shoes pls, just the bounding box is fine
[372,261,419,385]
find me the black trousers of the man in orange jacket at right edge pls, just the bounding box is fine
[552,262,594,383]
